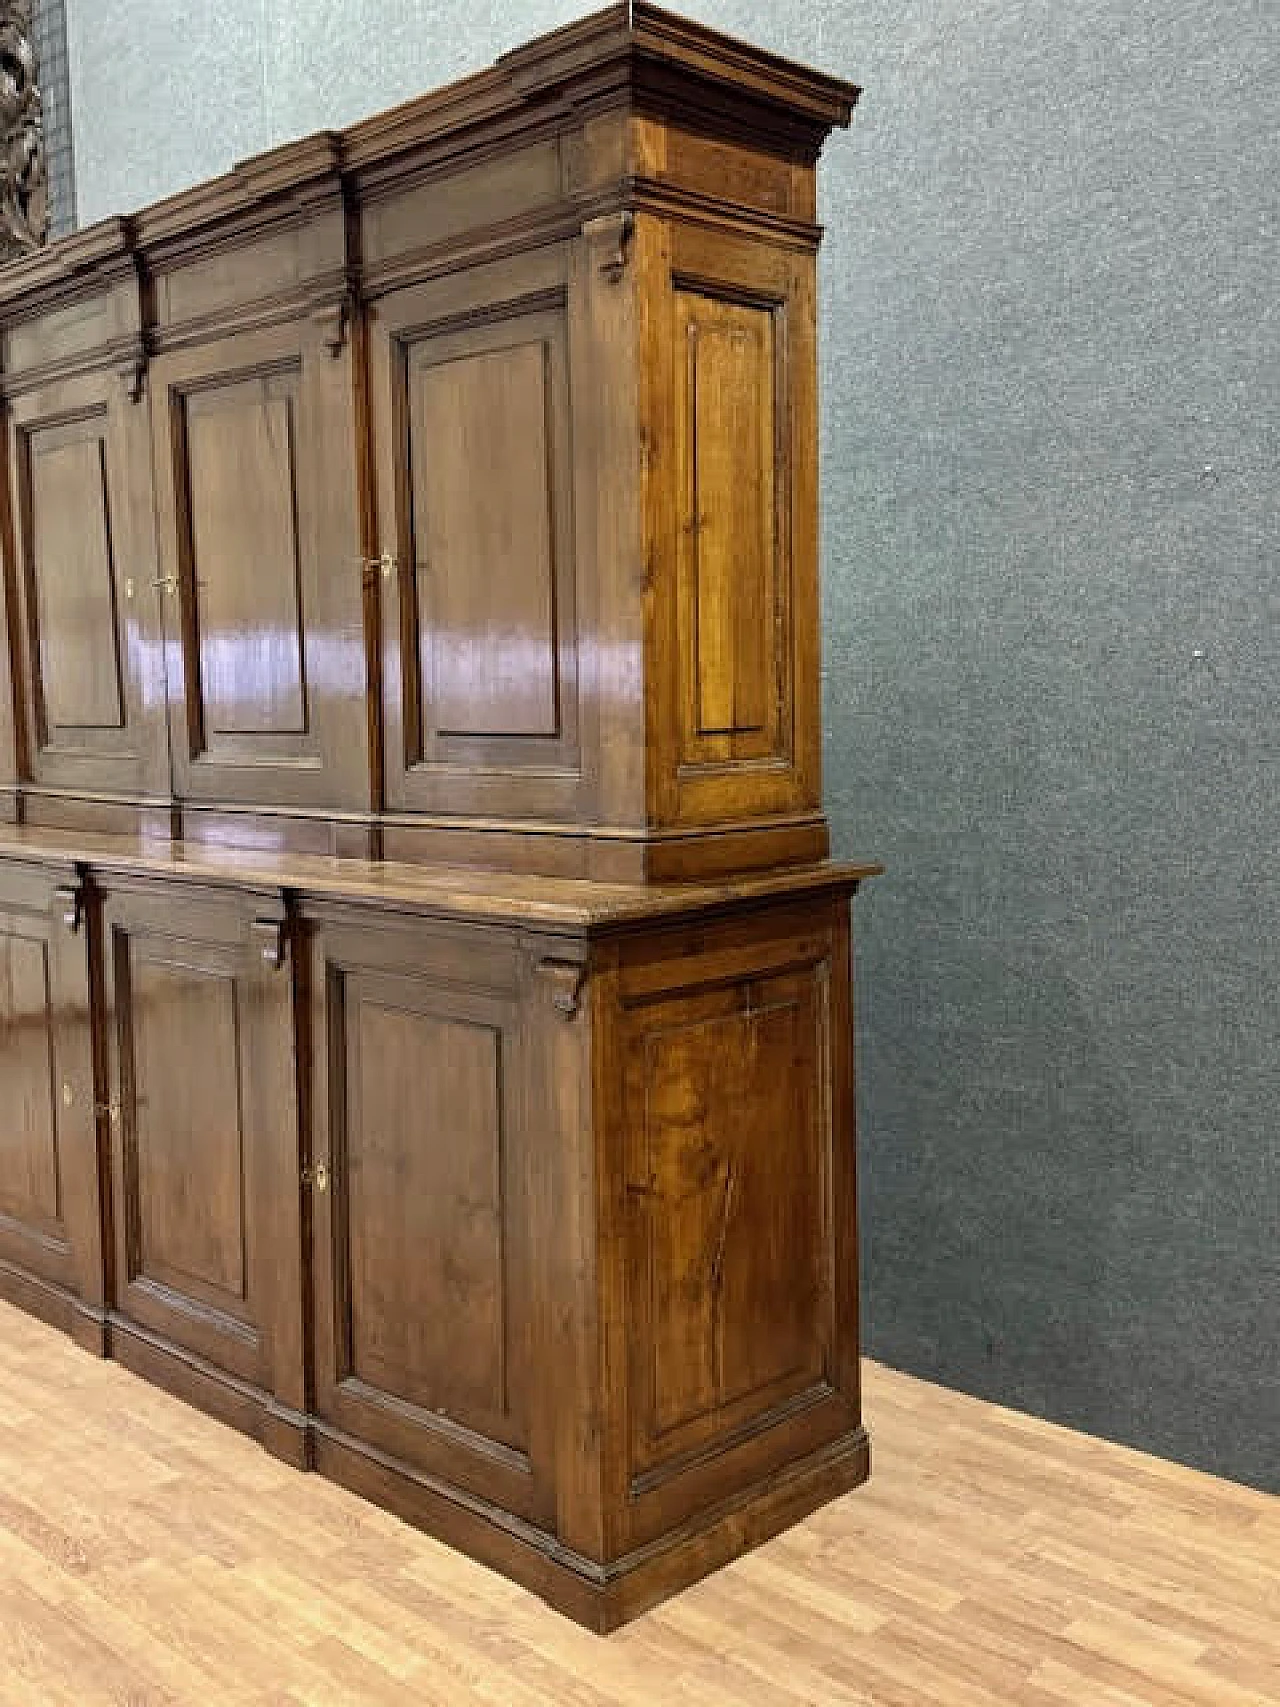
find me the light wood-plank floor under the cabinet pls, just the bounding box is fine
[0,1306,1280,1707]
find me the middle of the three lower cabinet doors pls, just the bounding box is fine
[104,884,304,1410]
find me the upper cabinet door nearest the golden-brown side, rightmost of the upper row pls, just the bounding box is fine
[370,251,580,816]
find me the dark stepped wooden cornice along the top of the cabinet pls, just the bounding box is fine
[0,0,860,307]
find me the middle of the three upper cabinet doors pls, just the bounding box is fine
[152,326,370,811]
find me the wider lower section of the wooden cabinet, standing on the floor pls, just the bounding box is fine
[0,864,867,1630]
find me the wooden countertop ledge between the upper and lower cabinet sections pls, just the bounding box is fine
[0,826,884,935]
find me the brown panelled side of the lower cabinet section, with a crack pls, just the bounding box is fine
[604,900,858,1547]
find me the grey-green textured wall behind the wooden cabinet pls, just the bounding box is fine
[67,0,1280,1490]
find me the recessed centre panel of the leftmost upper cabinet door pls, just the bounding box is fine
[27,425,125,744]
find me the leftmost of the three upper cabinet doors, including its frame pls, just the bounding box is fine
[10,374,169,797]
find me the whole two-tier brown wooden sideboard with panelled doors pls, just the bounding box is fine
[0,3,879,1630]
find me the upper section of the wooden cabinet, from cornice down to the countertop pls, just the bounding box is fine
[0,5,857,879]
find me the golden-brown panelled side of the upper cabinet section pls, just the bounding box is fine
[637,217,821,828]
